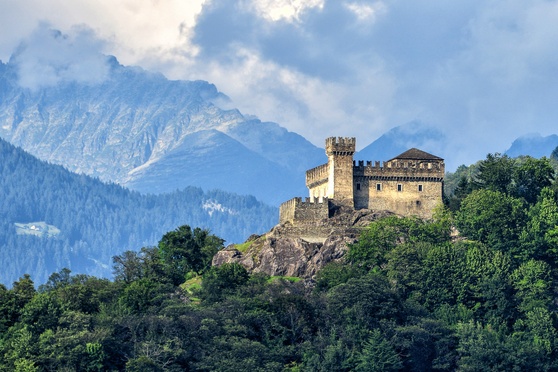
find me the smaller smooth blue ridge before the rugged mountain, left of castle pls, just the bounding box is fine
[126,129,304,204]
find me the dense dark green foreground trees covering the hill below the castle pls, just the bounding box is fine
[0,150,558,371]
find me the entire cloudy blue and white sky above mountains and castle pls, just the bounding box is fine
[0,0,558,169]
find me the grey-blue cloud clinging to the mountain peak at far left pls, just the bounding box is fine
[11,24,109,90]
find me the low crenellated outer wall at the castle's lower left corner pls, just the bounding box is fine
[279,197,329,224]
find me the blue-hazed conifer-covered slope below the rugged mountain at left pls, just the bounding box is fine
[0,139,278,285]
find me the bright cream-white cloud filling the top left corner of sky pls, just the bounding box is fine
[0,0,204,64]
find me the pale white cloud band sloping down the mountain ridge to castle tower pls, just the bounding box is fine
[190,47,395,146]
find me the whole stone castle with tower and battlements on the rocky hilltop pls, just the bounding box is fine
[279,137,445,225]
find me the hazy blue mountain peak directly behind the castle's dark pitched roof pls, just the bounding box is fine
[355,121,445,161]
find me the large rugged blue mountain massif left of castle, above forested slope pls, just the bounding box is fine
[0,57,324,204]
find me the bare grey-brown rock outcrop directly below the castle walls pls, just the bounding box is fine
[213,209,394,278]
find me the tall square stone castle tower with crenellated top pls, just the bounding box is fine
[326,137,356,208]
